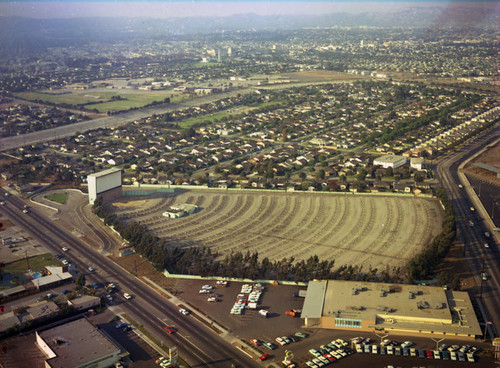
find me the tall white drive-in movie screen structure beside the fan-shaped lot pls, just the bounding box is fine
[87,168,122,204]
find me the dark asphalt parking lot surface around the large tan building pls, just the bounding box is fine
[177,280,493,367]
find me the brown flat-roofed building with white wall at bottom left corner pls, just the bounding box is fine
[36,318,128,368]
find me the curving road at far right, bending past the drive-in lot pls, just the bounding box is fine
[437,124,500,337]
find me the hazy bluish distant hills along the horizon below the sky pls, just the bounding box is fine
[0,2,500,56]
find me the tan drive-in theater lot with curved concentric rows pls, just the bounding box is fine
[115,190,443,270]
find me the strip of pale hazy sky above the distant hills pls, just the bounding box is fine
[0,0,454,18]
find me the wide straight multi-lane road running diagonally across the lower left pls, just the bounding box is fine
[0,189,260,368]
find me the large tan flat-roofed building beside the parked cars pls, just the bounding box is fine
[302,280,482,340]
